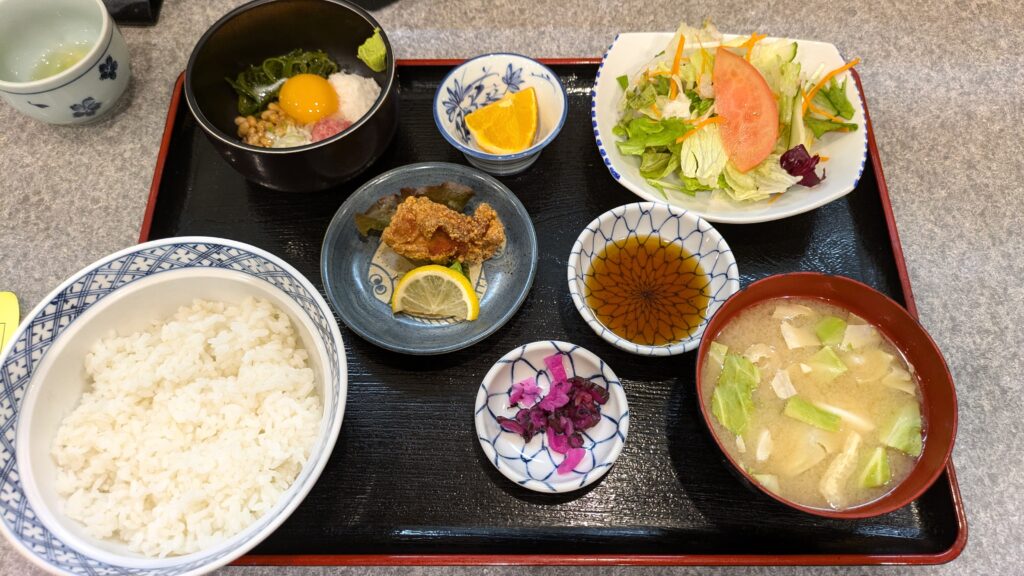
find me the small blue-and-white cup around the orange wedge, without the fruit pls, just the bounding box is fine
[434,53,569,175]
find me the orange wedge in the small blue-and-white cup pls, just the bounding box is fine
[466,88,537,154]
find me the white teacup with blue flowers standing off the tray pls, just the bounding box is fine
[0,0,131,124]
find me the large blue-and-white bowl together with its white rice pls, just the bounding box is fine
[0,237,347,575]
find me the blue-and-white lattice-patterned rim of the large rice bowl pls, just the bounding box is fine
[0,236,348,576]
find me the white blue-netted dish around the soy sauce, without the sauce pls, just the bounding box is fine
[567,202,739,356]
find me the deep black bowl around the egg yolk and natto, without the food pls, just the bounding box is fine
[184,0,398,192]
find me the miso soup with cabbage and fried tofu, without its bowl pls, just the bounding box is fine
[701,298,924,509]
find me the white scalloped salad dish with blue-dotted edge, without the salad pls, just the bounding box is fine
[591,32,867,223]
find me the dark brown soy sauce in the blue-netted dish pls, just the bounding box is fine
[584,236,711,346]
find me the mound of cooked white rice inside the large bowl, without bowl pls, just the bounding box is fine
[52,298,323,557]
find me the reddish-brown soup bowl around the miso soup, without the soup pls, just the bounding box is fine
[696,272,956,520]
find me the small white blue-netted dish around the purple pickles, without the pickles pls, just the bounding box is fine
[473,340,631,493]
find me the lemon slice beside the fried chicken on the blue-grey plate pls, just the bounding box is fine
[391,264,480,320]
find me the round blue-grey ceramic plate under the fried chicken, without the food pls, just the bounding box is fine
[321,162,537,355]
